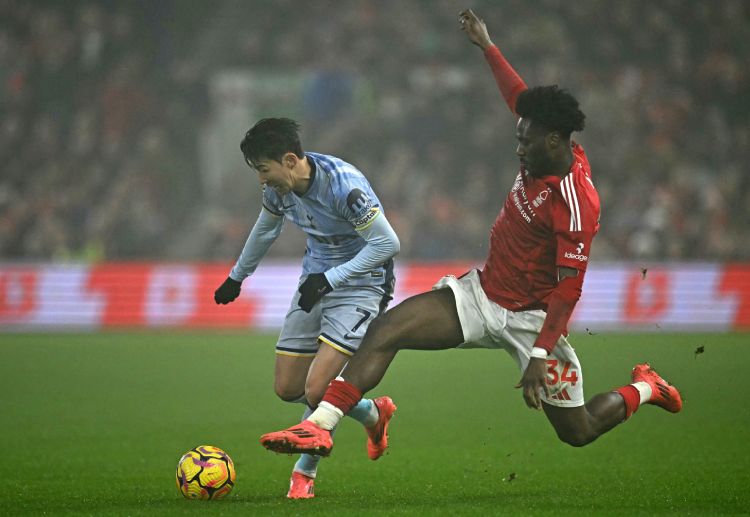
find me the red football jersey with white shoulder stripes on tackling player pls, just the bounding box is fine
[480,142,599,311]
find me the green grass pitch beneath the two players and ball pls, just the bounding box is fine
[0,332,750,516]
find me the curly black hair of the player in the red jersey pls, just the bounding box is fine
[516,84,586,138]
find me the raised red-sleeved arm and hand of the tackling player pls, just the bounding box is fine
[458,9,528,114]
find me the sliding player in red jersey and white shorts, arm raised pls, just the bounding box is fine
[261,10,682,456]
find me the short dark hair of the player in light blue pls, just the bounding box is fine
[240,118,305,167]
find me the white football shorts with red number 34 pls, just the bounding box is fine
[433,269,584,407]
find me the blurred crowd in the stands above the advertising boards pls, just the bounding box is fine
[0,0,750,262]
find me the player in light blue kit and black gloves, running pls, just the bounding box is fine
[214,118,400,499]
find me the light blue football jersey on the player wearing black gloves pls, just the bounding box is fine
[263,152,393,285]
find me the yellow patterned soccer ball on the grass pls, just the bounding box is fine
[177,445,236,500]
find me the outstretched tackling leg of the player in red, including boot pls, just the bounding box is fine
[261,289,464,456]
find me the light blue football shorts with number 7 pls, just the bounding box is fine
[276,276,391,357]
